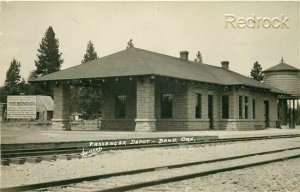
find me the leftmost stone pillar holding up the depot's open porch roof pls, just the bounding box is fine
[52,84,71,131]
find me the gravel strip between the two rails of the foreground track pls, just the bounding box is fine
[48,149,300,191]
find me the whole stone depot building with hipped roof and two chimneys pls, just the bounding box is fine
[31,47,284,131]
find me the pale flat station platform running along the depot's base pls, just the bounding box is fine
[1,127,300,144]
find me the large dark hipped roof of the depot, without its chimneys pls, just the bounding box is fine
[30,47,284,93]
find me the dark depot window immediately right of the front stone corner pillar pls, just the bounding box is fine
[160,93,173,118]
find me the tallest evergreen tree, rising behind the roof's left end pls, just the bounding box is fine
[31,26,63,96]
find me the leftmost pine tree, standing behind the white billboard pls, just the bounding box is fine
[4,59,21,95]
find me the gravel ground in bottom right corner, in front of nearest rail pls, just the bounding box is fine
[134,158,300,192]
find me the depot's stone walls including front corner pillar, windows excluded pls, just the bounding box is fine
[100,77,277,131]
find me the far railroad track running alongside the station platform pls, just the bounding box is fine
[1,134,300,165]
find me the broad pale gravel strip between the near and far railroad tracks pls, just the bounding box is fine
[1,138,300,187]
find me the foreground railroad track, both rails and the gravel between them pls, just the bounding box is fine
[1,147,300,192]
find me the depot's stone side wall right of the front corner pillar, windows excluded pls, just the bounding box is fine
[156,81,277,131]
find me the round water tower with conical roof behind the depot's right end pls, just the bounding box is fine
[264,58,300,128]
